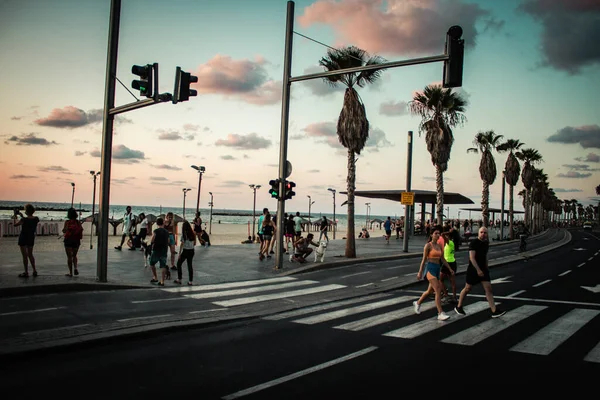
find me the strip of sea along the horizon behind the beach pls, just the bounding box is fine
[0,200,387,228]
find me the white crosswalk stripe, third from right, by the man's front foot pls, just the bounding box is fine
[441,305,548,346]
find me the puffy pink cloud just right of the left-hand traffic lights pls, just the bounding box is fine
[193,54,282,105]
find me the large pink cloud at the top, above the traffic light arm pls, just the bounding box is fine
[298,0,492,55]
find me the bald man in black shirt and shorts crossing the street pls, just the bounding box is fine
[454,226,506,318]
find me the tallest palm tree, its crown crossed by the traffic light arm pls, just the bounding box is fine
[319,46,383,258]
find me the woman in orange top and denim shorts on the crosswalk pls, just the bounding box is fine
[413,226,454,321]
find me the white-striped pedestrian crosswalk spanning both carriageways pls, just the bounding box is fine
[162,277,600,363]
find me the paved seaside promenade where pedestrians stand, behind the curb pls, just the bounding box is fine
[0,230,562,297]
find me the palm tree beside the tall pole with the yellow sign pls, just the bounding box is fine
[409,85,467,225]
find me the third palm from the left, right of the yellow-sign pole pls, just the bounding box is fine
[467,131,504,228]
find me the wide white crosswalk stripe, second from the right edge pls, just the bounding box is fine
[506,308,600,356]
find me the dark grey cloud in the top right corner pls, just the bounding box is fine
[519,0,600,74]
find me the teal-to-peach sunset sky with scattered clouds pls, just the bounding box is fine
[0,0,600,218]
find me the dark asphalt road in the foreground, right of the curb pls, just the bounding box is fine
[0,231,600,399]
